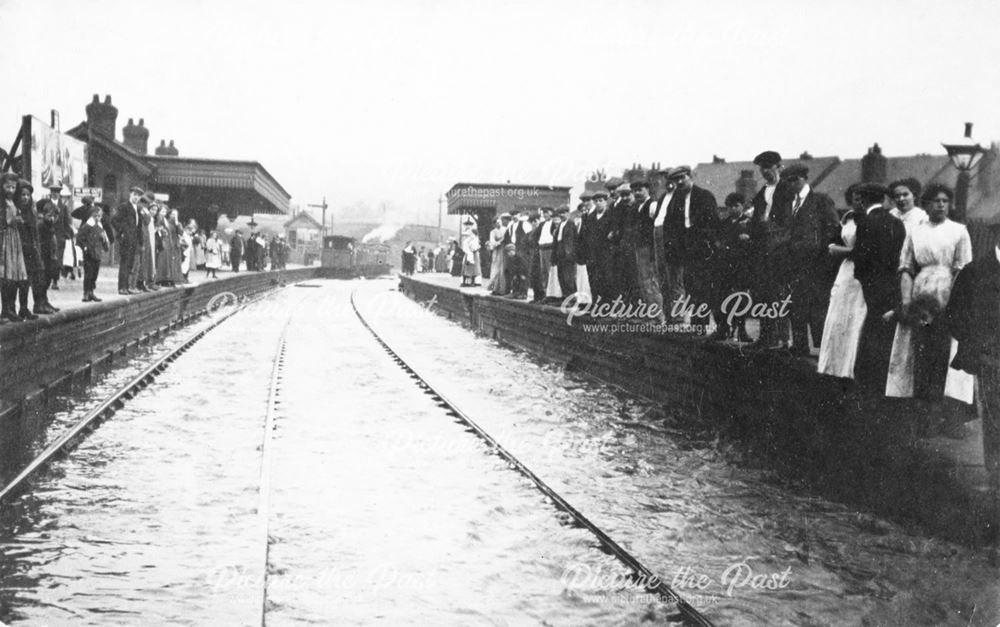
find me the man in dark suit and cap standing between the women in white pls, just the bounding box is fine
[852,183,906,396]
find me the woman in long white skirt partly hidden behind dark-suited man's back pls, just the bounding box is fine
[816,186,868,379]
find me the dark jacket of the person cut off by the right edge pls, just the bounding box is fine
[947,249,1000,374]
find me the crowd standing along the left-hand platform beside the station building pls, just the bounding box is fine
[0,179,290,323]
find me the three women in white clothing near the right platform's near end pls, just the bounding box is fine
[818,179,972,432]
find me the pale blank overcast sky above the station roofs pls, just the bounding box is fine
[0,0,1000,223]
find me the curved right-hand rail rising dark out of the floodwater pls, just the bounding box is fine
[351,291,712,627]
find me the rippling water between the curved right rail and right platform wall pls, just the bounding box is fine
[352,286,1000,627]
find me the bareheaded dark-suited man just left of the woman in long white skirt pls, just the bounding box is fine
[774,165,840,357]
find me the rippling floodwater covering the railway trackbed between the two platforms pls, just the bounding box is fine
[0,281,1000,627]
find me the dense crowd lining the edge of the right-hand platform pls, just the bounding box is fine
[410,151,1000,436]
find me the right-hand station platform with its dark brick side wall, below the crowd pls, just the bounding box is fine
[400,273,998,545]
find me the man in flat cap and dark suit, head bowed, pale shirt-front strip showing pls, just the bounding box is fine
[663,165,719,322]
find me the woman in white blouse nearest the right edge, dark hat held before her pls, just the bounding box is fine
[885,184,972,403]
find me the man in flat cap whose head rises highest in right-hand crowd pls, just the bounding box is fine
[750,150,793,348]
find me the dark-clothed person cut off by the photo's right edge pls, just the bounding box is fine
[947,246,1000,502]
